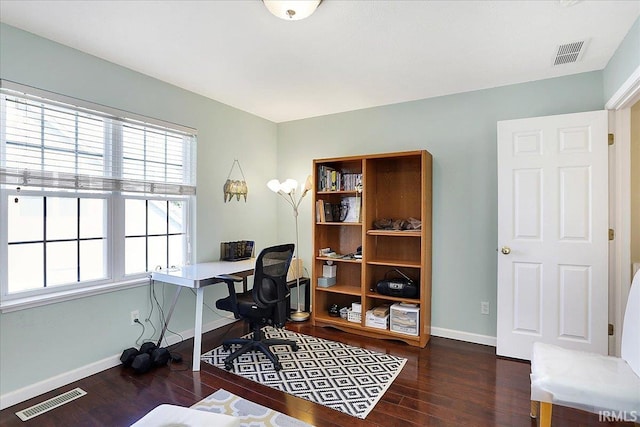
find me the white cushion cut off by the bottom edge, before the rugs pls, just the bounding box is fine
[131,405,240,427]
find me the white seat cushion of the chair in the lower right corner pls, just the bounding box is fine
[531,342,640,413]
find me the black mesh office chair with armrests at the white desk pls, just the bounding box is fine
[216,244,298,371]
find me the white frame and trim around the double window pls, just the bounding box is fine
[0,80,197,313]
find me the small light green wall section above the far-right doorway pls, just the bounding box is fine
[603,18,640,103]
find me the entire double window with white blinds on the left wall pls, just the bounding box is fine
[0,81,196,303]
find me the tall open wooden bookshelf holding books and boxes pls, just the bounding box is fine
[312,150,432,347]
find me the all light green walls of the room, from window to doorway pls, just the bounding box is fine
[5,13,640,402]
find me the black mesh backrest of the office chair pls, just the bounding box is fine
[253,243,294,308]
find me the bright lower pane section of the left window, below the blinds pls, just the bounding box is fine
[6,196,107,293]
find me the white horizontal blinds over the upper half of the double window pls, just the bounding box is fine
[0,82,196,195]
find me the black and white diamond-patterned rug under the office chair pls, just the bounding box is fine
[201,327,407,419]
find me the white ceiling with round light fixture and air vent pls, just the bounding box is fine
[0,0,640,122]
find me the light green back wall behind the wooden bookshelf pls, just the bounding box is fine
[278,72,603,337]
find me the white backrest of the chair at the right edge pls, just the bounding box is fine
[620,270,640,377]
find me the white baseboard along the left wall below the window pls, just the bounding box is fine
[0,318,236,410]
